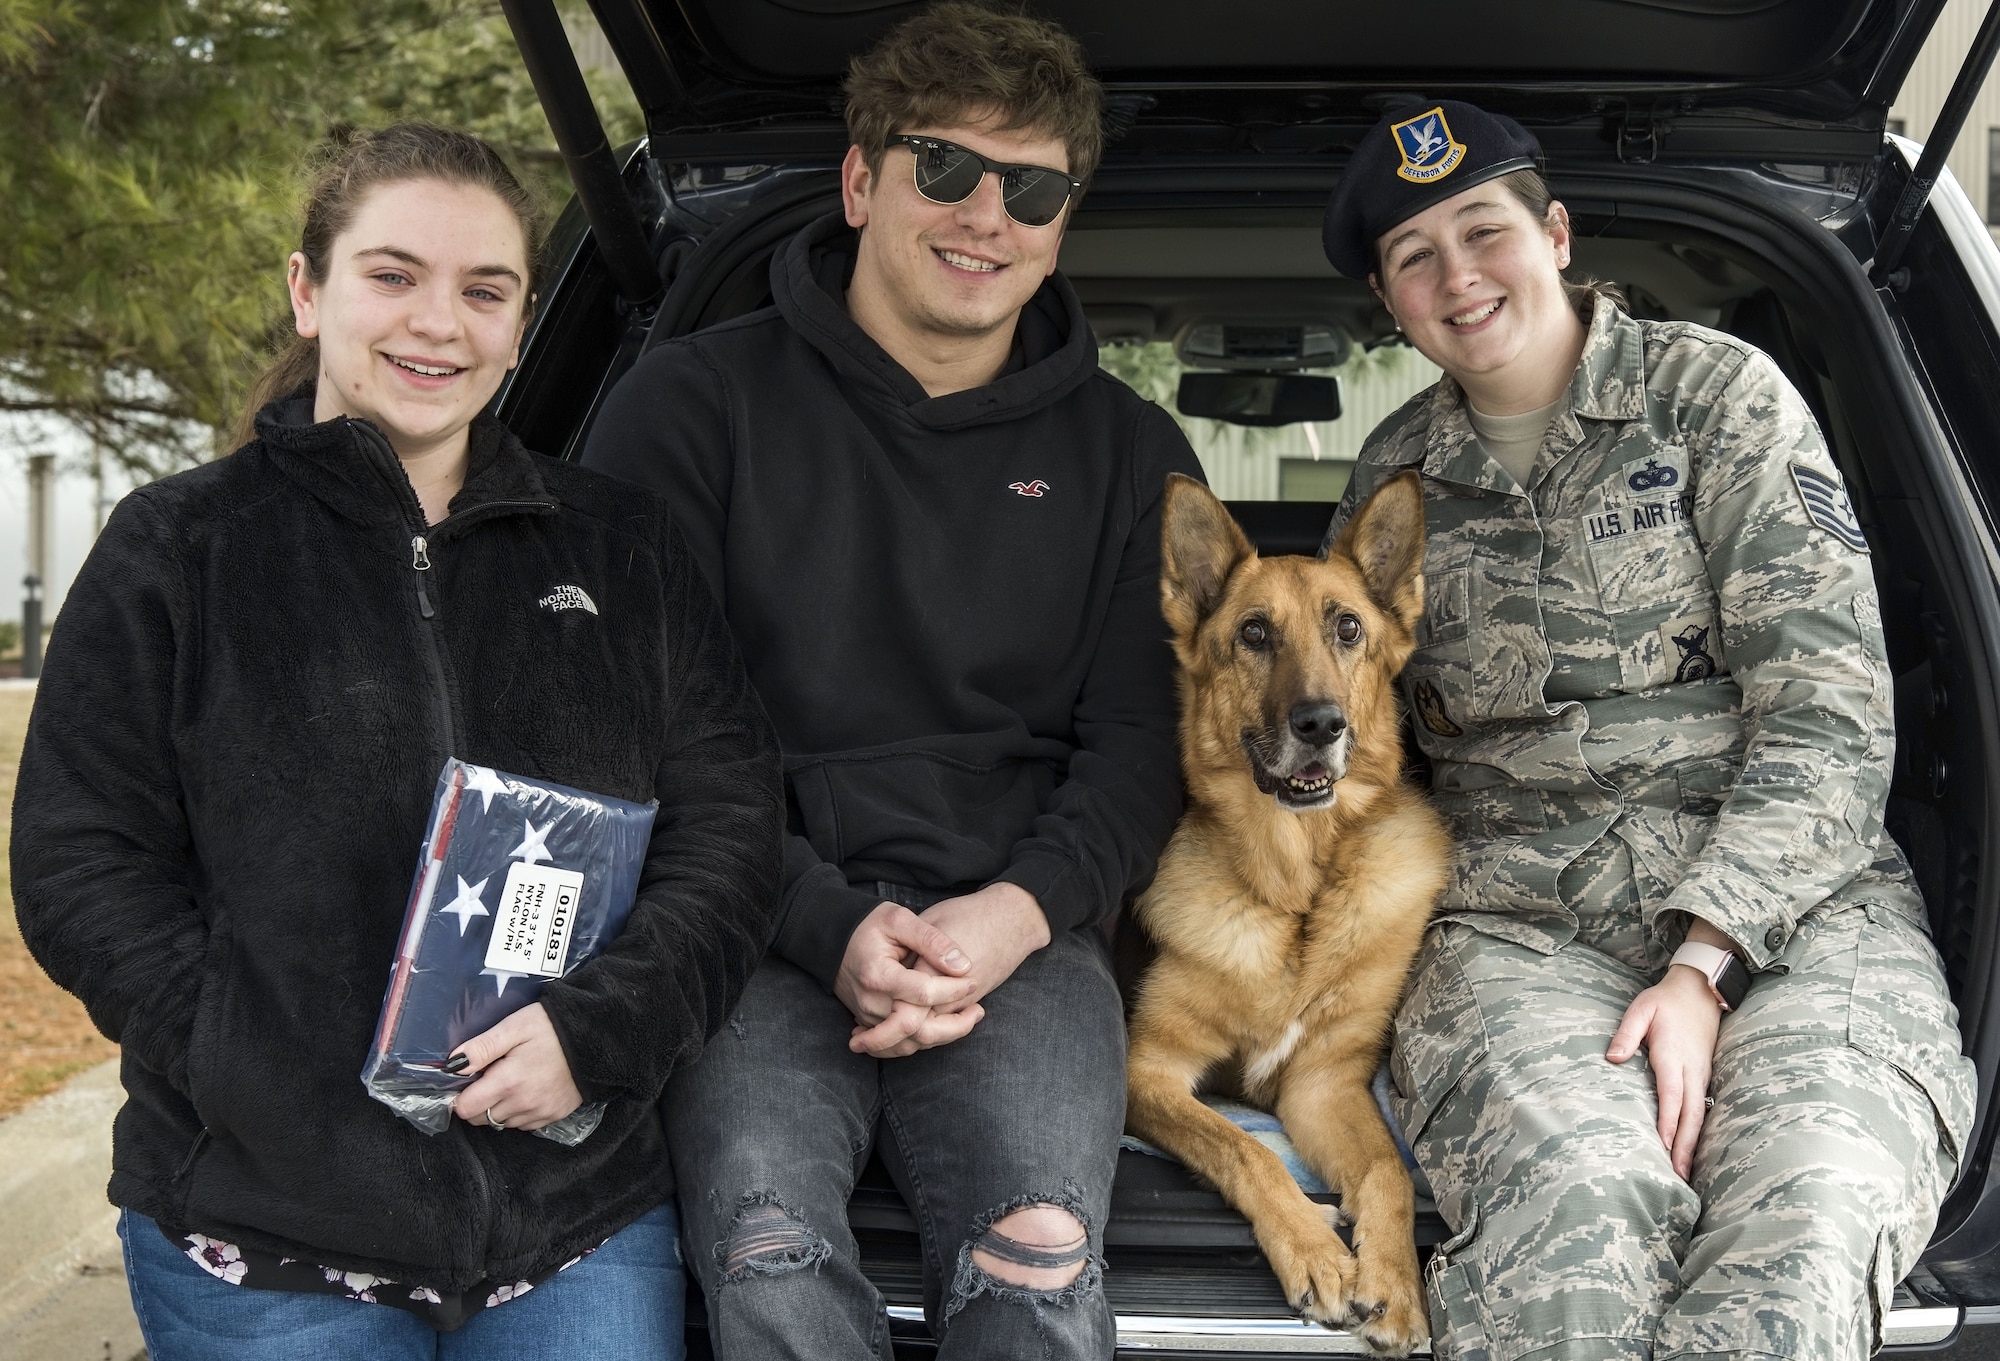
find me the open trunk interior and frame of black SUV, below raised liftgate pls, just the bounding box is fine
[502,130,2000,1355]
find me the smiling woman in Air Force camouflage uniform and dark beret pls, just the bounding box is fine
[1326,102,1974,1361]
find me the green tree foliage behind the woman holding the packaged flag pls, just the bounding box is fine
[0,0,640,476]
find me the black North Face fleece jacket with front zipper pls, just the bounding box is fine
[12,398,782,1289]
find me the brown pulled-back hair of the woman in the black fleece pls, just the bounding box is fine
[230,122,546,448]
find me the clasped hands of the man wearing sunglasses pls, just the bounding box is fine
[834,883,1050,1059]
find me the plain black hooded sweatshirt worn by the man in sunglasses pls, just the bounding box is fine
[584,214,1200,985]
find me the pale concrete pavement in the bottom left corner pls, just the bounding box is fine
[0,1059,146,1361]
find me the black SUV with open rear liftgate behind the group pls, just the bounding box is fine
[500,0,2000,1357]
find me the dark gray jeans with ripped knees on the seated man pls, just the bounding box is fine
[662,895,1126,1361]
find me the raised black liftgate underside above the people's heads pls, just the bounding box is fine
[596,0,1942,160]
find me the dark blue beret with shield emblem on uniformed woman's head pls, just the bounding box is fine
[1320,100,1542,278]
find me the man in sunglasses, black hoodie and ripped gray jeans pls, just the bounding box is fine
[584,4,1200,1361]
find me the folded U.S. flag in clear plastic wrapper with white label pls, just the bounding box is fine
[362,757,658,1145]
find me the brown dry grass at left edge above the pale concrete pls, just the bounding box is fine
[0,687,118,1117]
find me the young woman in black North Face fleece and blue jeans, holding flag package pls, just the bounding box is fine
[12,126,782,1361]
